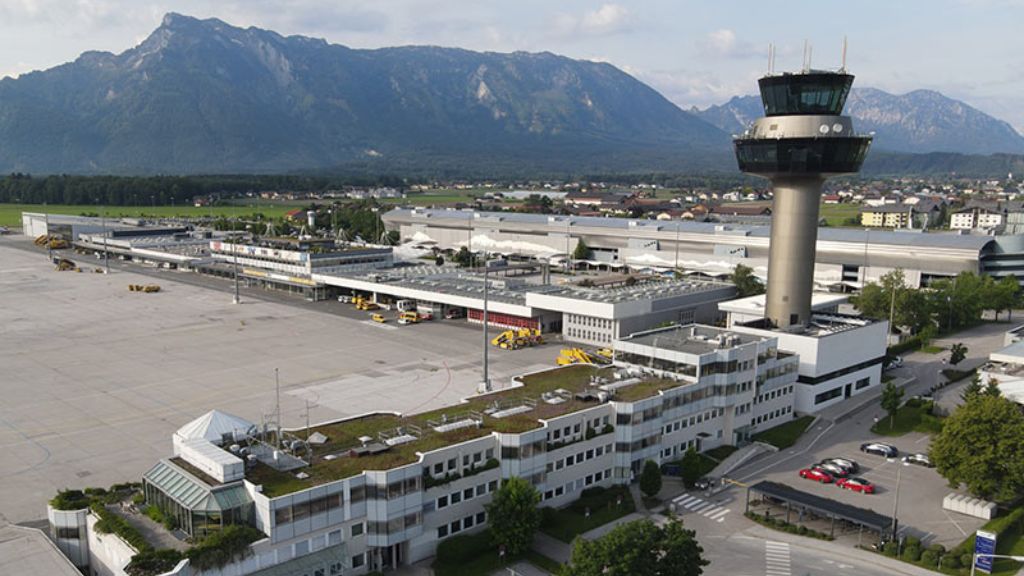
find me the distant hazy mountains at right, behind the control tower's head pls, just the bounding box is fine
[691,86,1024,155]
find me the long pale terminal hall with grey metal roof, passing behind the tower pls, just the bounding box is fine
[383,208,1024,291]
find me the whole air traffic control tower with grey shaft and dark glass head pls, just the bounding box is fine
[734,63,871,330]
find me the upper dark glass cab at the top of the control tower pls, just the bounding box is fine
[758,73,853,116]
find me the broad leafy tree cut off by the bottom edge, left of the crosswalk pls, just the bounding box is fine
[563,519,709,576]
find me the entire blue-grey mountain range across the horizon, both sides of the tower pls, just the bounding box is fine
[0,13,1024,177]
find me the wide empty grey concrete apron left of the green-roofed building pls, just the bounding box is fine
[0,236,559,524]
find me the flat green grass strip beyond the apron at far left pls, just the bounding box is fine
[0,204,296,227]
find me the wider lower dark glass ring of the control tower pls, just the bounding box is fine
[735,136,871,174]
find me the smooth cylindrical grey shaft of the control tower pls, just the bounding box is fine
[765,175,824,327]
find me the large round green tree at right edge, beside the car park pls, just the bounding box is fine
[930,395,1024,500]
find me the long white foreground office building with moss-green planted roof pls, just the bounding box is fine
[49,325,799,576]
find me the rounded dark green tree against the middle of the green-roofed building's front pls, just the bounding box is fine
[484,477,541,557]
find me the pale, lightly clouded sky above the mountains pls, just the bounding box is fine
[6,0,1024,132]
